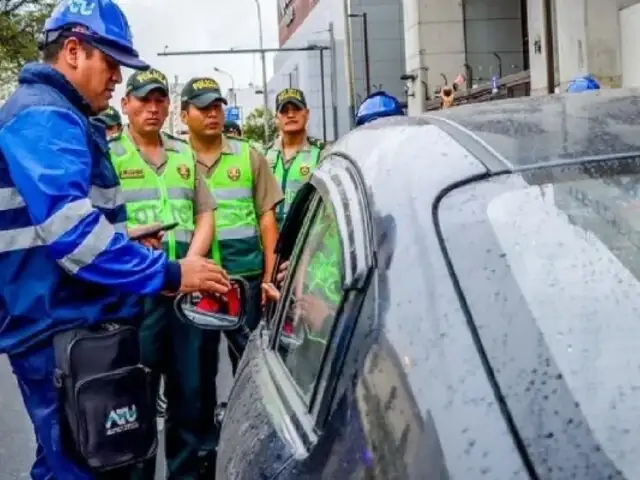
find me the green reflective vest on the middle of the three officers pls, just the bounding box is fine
[207,138,263,276]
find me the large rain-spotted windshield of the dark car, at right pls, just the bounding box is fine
[439,162,640,479]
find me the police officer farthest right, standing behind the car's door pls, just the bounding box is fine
[266,88,324,226]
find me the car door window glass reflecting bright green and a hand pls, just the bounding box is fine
[276,197,344,403]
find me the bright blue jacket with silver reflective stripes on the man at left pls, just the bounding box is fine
[0,63,180,354]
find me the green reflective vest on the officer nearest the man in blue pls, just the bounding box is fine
[109,135,196,260]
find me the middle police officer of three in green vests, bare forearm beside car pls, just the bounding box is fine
[181,78,283,373]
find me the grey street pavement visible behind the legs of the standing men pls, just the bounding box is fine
[0,341,232,480]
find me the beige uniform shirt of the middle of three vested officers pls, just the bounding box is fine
[196,136,284,217]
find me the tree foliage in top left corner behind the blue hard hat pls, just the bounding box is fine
[0,0,56,84]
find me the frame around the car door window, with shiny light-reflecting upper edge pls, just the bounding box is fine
[258,153,375,455]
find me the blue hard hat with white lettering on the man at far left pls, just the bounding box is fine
[42,0,149,70]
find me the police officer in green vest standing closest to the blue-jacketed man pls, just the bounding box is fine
[110,69,216,479]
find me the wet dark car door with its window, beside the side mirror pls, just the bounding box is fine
[217,156,372,480]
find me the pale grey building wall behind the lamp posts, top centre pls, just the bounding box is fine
[268,0,405,140]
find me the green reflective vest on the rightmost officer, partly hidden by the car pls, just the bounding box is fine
[267,146,321,226]
